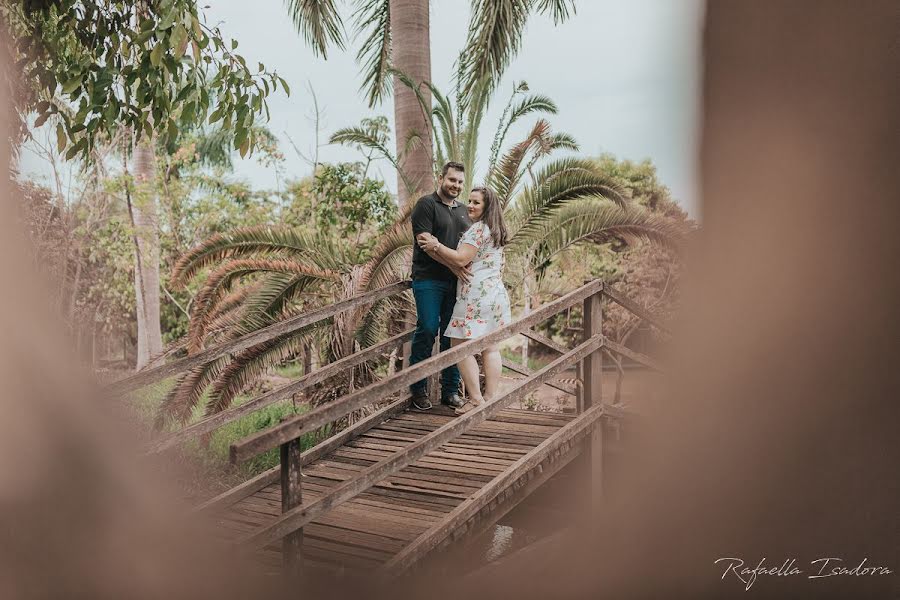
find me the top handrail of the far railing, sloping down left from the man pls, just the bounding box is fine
[107,281,410,394]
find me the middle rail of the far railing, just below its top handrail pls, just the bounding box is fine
[147,329,413,454]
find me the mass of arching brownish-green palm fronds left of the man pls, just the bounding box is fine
[158,215,409,425]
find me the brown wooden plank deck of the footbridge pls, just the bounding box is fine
[217,406,574,571]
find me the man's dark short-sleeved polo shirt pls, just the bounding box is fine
[411,192,472,281]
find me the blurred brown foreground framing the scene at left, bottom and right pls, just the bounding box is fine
[0,0,900,599]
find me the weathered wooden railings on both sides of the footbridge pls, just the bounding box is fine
[111,280,666,574]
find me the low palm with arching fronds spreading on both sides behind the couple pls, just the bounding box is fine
[160,79,677,422]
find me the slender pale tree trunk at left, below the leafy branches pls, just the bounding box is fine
[132,138,162,369]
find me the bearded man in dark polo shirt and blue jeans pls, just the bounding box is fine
[409,162,472,410]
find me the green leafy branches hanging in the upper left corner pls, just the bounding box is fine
[0,0,287,159]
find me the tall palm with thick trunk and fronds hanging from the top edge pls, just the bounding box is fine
[288,0,575,207]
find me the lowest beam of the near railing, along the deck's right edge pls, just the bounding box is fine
[376,405,603,577]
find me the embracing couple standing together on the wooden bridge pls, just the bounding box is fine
[409,162,511,412]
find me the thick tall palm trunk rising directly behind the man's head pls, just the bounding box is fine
[390,0,434,209]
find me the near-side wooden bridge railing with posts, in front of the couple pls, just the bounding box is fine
[223,281,656,573]
